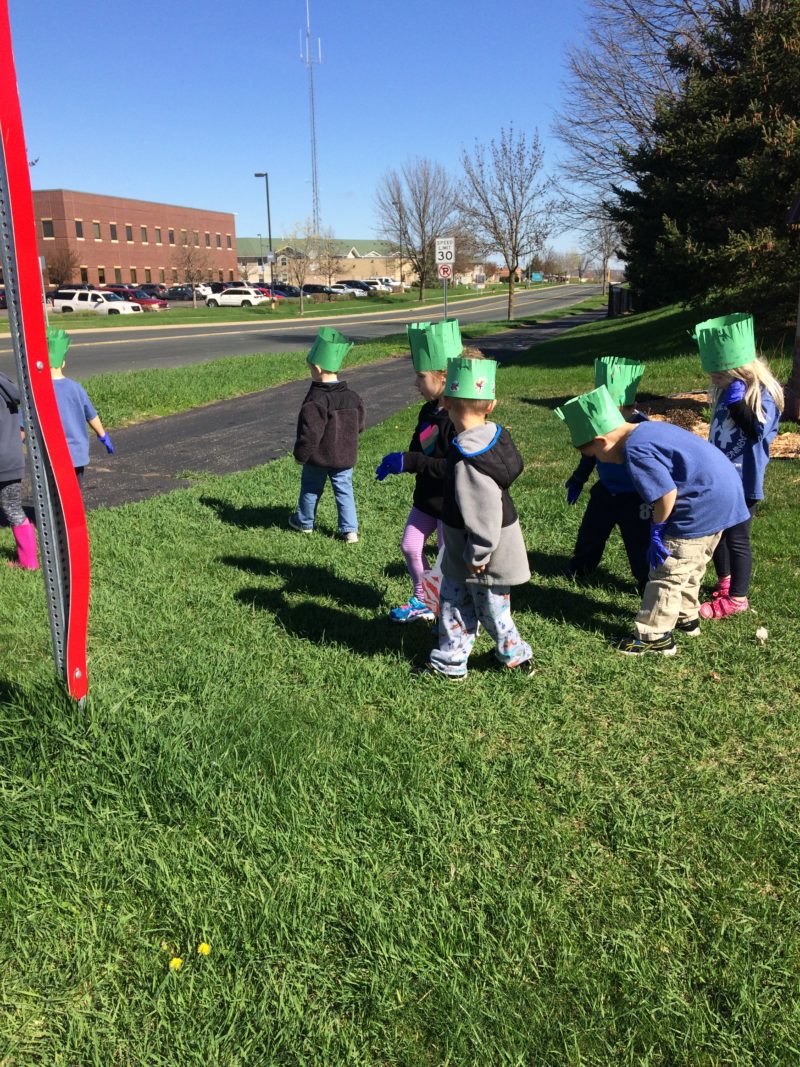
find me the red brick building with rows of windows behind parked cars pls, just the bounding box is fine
[33,189,239,285]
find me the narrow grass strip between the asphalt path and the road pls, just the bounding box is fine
[82,300,598,429]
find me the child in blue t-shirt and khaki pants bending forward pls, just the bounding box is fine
[556,385,748,656]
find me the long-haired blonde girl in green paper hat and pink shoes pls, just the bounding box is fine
[694,314,783,619]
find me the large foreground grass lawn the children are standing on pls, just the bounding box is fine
[0,312,800,1067]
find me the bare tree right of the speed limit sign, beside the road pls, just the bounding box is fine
[459,126,556,318]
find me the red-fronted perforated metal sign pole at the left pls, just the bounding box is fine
[0,0,90,700]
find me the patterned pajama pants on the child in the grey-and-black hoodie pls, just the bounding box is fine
[430,578,533,676]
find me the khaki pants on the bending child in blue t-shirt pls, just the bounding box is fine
[634,532,722,641]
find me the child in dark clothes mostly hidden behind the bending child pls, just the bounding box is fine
[564,355,650,594]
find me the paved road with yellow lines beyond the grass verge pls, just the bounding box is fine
[0,285,599,379]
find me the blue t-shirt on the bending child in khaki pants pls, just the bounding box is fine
[625,423,750,538]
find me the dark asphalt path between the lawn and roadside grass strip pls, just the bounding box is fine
[70,310,605,510]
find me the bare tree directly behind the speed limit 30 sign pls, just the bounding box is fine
[375,159,455,300]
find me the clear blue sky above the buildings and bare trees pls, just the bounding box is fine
[10,0,581,248]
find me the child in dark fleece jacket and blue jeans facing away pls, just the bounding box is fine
[289,327,364,544]
